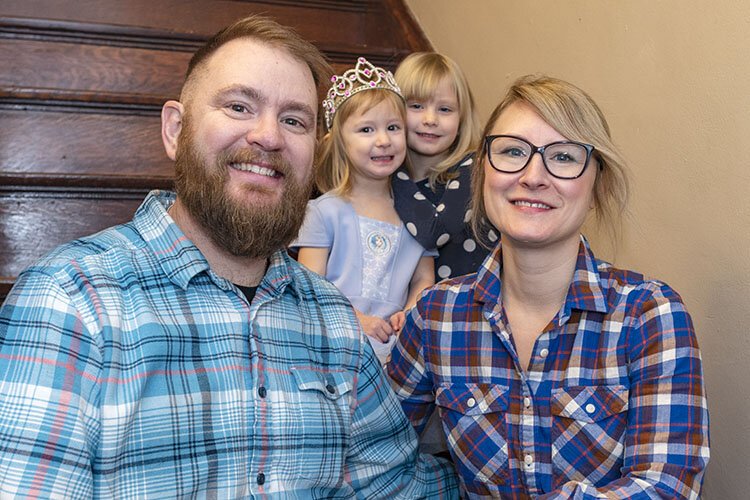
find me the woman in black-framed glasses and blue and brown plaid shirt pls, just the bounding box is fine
[388,77,709,499]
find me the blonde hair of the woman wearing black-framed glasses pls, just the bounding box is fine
[471,75,629,248]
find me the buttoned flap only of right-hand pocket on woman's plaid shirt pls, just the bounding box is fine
[551,385,629,422]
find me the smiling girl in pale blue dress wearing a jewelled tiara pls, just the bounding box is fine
[292,57,437,362]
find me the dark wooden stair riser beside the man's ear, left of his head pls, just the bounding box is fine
[0,109,173,180]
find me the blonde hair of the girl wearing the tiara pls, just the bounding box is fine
[315,89,406,196]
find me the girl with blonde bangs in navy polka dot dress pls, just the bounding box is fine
[392,52,498,279]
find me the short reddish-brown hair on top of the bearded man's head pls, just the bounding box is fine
[182,15,333,100]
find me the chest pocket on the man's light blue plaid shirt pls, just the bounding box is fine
[286,366,353,487]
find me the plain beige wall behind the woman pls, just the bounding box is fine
[406,0,750,500]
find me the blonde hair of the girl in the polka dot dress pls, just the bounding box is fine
[395,52,479,186]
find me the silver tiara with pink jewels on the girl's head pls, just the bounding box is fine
[323,57,404,130]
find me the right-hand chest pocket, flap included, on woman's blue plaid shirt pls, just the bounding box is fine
[550,385,629,485]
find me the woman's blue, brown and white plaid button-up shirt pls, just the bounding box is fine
[387,238,709,499]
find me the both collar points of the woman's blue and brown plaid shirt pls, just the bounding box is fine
[472,235,608,319]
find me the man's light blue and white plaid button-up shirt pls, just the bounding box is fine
[0,193,458,499]
